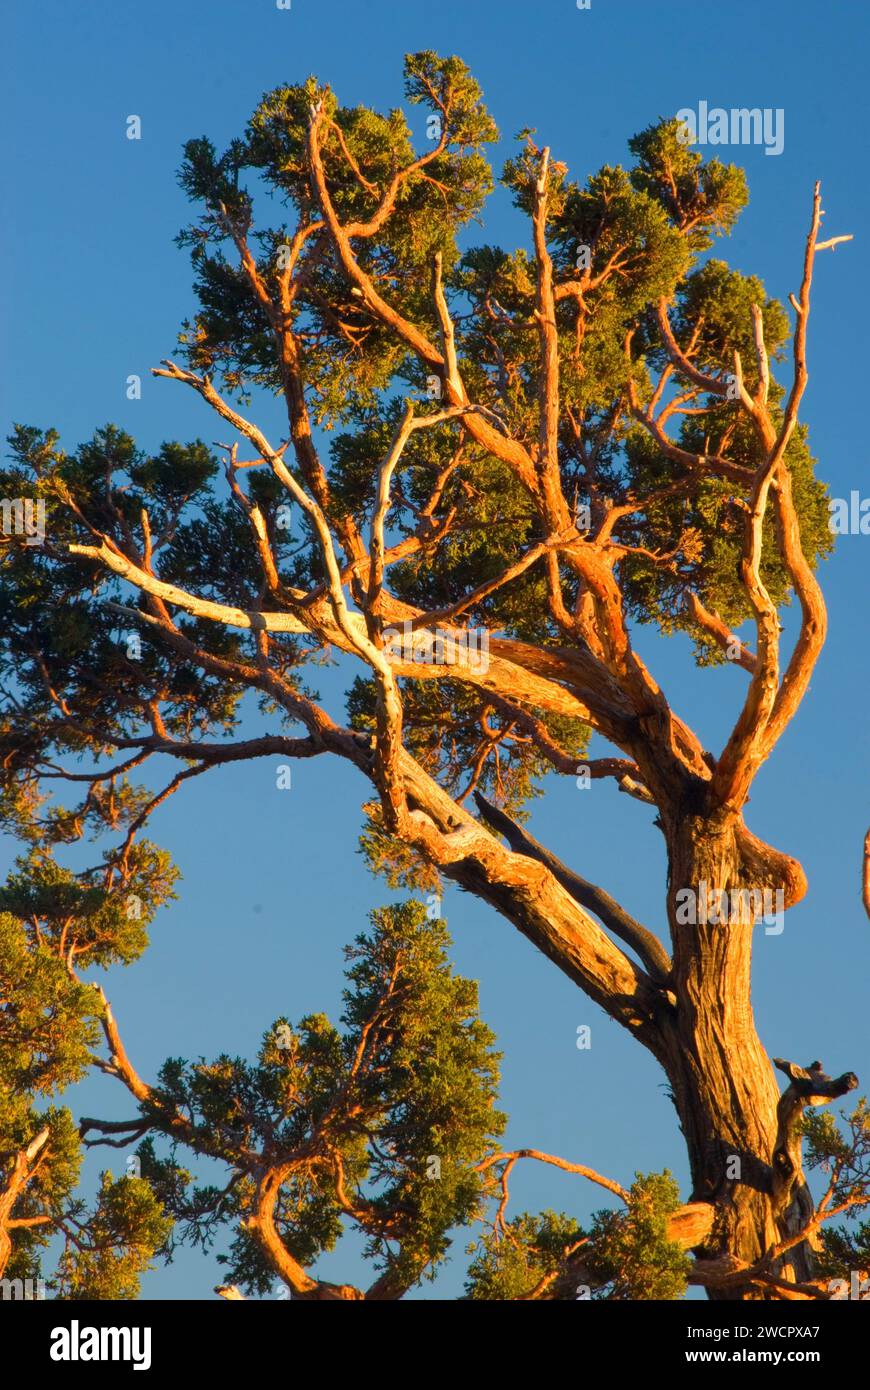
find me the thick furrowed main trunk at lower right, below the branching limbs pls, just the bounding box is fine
[666,816,810,1298]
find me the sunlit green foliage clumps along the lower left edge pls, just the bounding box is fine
[0,852,171,1300]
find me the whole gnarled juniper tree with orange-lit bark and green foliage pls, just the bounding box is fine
[1,53,870,1298]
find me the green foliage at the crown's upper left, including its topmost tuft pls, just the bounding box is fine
[179,53,498,425]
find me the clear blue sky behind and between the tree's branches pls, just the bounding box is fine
[0,0,870,1298]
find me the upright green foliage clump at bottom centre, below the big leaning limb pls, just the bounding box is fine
[134,902,504,1293]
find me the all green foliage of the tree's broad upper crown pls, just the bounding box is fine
[0,62,831,863]
